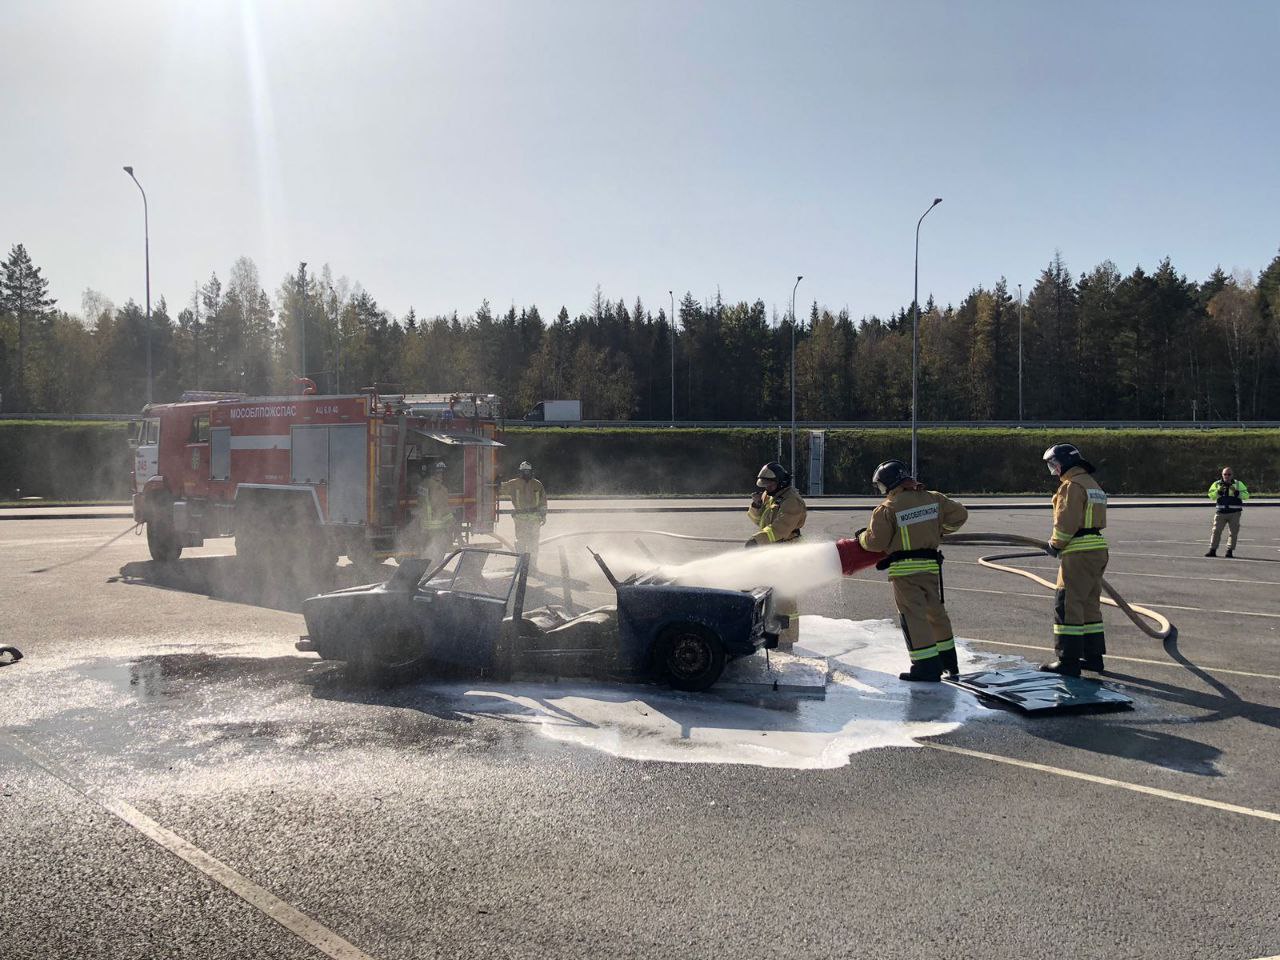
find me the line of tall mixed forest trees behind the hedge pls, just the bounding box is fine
[0,243,1280,421]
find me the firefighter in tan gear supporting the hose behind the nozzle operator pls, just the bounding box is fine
[1041,443,1110,677]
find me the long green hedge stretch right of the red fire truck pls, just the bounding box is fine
[500,428,1280,494]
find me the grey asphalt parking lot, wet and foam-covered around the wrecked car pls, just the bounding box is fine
[0,500,1280,960]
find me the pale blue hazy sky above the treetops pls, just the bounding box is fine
[0,0,1280,323]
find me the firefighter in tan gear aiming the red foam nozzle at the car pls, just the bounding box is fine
[858,460,969,684]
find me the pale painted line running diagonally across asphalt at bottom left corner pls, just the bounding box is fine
[5,735,374,960]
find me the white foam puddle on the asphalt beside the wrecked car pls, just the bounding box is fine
[454,616,1001,769]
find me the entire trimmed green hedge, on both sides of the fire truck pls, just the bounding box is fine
[0,421,1280,499]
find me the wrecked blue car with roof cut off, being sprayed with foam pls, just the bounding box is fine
[297,547,778,690]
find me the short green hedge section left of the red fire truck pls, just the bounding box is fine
[0,420,133,500]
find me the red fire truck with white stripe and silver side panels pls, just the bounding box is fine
[133,387,503,571]
